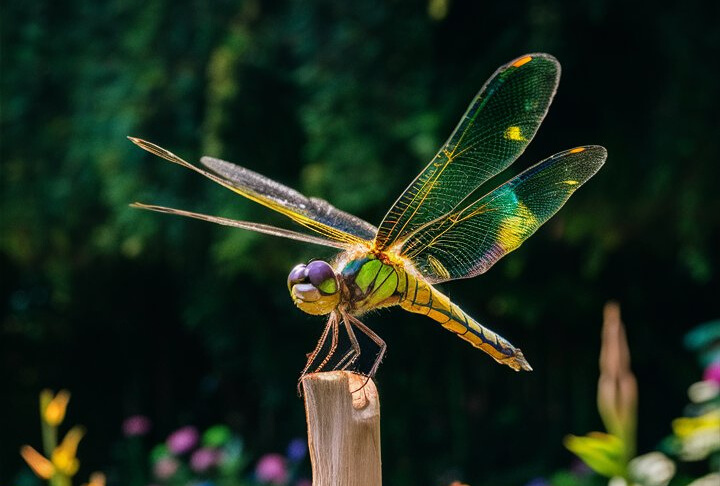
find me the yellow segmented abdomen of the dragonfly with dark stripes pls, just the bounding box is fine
[398,272,532,371]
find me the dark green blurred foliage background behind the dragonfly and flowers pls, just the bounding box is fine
[0,0,720,486]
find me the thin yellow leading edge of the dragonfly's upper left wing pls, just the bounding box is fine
[128,137,370,248]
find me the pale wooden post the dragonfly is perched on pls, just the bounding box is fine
[302,371,382,486]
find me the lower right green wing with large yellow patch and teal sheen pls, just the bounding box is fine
[400,146,607,283]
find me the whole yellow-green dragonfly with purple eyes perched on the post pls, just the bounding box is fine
[129,53,607,377]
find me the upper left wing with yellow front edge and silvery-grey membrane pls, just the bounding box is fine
[128,137,376,246]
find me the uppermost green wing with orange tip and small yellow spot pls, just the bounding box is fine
[374,54,560,250]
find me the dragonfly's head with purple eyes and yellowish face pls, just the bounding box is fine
[288,260,340,315]
